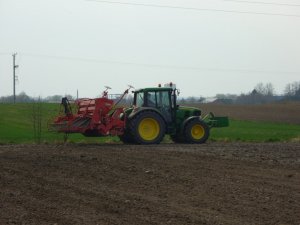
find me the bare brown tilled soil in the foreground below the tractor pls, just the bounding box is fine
[0,143,300,225]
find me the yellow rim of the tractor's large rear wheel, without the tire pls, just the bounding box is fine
[138,118,160,141]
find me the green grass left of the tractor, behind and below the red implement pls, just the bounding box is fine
[0,103,115,143]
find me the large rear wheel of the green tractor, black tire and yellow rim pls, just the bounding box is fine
[129,111,166,145]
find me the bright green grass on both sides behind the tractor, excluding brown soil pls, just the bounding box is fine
[0,103,300,144]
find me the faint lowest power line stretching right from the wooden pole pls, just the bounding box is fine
[22,53,300,74]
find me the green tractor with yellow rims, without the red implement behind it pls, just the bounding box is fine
[119,84,229,144]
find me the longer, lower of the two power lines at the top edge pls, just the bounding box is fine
[86,0,300,18]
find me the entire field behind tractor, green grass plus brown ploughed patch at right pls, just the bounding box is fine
[0,103,300,143]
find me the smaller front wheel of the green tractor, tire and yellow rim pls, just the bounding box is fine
[183,118,209,144]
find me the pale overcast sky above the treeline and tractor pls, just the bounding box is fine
[0,0,300,97]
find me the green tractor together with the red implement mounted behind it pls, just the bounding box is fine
[51,83,229,145]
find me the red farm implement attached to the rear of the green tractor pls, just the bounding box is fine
[51,89,129,137]
